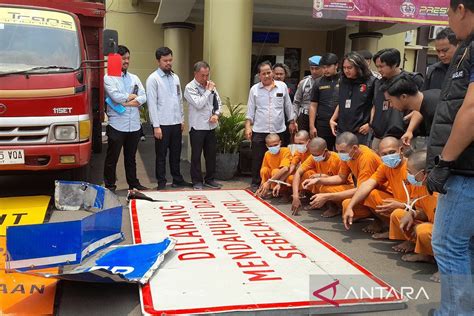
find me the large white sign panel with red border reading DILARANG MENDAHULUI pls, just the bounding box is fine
[130,190,405,315]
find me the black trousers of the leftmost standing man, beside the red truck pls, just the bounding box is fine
[104,125,142,189]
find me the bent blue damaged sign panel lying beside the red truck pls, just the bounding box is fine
[7,181,123,271]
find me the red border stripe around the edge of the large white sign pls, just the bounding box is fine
[131,189,402,315]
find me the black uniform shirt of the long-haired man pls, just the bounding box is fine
[337,76,376,144]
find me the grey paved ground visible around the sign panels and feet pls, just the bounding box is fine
[0,138,440,315]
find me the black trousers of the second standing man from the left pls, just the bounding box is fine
[155,124,184,184]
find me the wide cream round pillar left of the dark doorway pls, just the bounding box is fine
[203,0,253,104]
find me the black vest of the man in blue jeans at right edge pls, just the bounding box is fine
[426,36,474,176]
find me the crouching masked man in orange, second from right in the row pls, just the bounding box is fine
[343,136,407,239]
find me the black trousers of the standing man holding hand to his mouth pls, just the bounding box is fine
[189,128,217,184]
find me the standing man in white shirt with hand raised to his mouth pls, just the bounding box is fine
[184,61,222,190]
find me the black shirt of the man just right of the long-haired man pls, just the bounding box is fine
[371,70,423,139]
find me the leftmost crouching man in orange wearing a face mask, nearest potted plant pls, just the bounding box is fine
[255,133,291,198]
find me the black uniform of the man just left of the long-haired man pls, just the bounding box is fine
[311,74,340,150]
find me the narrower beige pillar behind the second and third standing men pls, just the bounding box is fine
[162,22,195,87]
